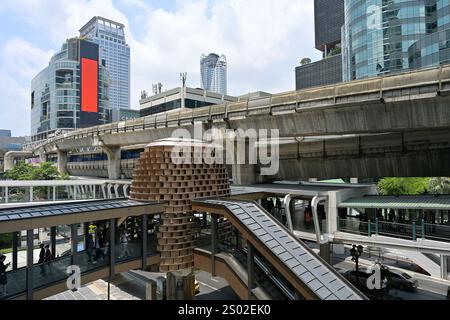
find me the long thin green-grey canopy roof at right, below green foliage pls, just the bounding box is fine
[338,195,450,210]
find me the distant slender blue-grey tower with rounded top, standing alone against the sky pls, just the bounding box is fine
[200,53,227,95]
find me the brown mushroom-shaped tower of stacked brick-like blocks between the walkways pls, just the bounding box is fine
[130,139,230,272]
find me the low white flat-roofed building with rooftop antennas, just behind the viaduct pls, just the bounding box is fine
[139,87,238,117]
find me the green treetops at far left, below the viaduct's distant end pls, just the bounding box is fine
[5,161,69,180]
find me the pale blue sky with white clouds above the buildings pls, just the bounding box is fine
[0,0,320,136]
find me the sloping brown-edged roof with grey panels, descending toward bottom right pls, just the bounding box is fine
[192,199,367,300]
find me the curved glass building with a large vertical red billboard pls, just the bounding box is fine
[31,38,110,142]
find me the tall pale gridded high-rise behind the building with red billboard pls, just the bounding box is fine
[80,17,130,110]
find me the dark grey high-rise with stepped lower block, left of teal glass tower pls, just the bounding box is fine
[295,0,344,90]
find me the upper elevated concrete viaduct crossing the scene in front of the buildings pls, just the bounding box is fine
[21,66,450,179]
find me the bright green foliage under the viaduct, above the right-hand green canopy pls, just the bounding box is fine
[378,178,431,196]
